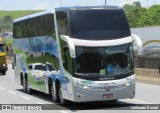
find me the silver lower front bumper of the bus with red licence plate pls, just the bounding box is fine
[74,84,135,102]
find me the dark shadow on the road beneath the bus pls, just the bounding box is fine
[17,89,142,111]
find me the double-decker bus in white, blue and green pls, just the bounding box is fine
[13,6,142,104]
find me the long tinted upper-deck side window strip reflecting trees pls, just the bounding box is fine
[13,14,55,38]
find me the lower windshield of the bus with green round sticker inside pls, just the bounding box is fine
[74,44,134,80]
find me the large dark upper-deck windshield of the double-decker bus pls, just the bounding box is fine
[69,9,131,40]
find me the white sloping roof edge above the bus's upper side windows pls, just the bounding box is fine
[13,9,55,23]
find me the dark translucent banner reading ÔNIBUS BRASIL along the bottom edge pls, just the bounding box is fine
[0,103,160,111]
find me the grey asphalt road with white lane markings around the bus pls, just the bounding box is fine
[0,64,160,113]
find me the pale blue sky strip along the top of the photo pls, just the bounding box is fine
[0,0,160,10]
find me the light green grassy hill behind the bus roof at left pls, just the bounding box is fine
[0,10,42,19]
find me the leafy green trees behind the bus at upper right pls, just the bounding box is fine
[123,1,160,27]
